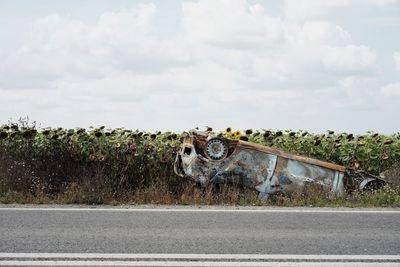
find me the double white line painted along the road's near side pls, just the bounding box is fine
[0,253,400,267]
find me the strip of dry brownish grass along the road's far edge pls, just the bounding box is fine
[0,181,400,207]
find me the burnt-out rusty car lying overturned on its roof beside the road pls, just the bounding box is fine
[174,131,385,199]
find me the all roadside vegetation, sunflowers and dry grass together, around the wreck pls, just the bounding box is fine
[0,120,400,207]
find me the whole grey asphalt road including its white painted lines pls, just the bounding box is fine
[0,206,400,266]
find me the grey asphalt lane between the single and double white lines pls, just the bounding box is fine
[0,208,400,255]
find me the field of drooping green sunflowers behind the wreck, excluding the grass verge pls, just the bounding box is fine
[0,122,400,203]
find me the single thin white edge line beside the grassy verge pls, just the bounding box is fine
[0,207,400,214]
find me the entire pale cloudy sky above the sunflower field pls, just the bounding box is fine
[0,0,400,134]
